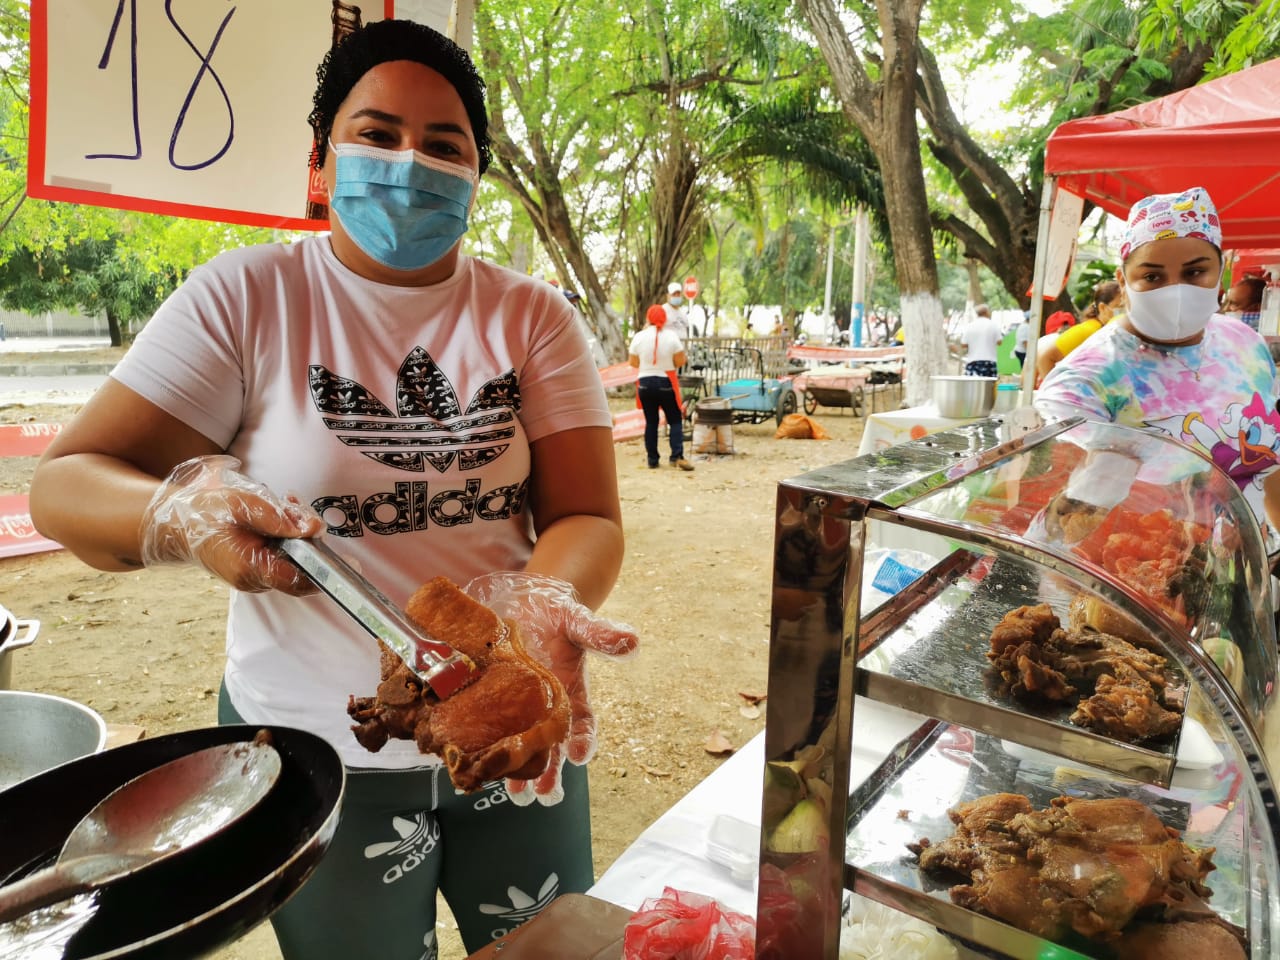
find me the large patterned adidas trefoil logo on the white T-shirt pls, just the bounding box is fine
[308,347,521,474]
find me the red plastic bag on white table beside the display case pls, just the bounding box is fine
[622,887,755,960]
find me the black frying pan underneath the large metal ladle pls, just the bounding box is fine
[0,724,346,960]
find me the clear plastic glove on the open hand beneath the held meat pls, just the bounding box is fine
[465,572,639,806]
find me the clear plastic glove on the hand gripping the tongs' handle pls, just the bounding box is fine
[138,454,324,596]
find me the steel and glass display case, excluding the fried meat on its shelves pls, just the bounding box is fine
[756,410,1280,960]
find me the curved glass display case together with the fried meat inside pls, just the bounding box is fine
[756,410,1280,960]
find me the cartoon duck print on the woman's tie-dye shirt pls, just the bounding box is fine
[1148,393,1280,493]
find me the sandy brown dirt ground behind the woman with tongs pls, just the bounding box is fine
[0,351,863,960]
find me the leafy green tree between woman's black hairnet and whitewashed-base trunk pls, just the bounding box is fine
[477,0,877,355]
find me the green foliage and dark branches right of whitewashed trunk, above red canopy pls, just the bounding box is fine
[920,0,1280,308]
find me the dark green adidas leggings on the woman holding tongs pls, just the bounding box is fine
[218,687,593,960]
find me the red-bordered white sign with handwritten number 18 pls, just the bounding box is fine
[27,0,475,229]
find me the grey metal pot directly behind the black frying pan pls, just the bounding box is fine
[0,690,106,790]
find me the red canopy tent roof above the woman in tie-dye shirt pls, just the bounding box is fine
[1044,59,1280,250]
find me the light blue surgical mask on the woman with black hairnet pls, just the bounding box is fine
[329,141,476,270]
